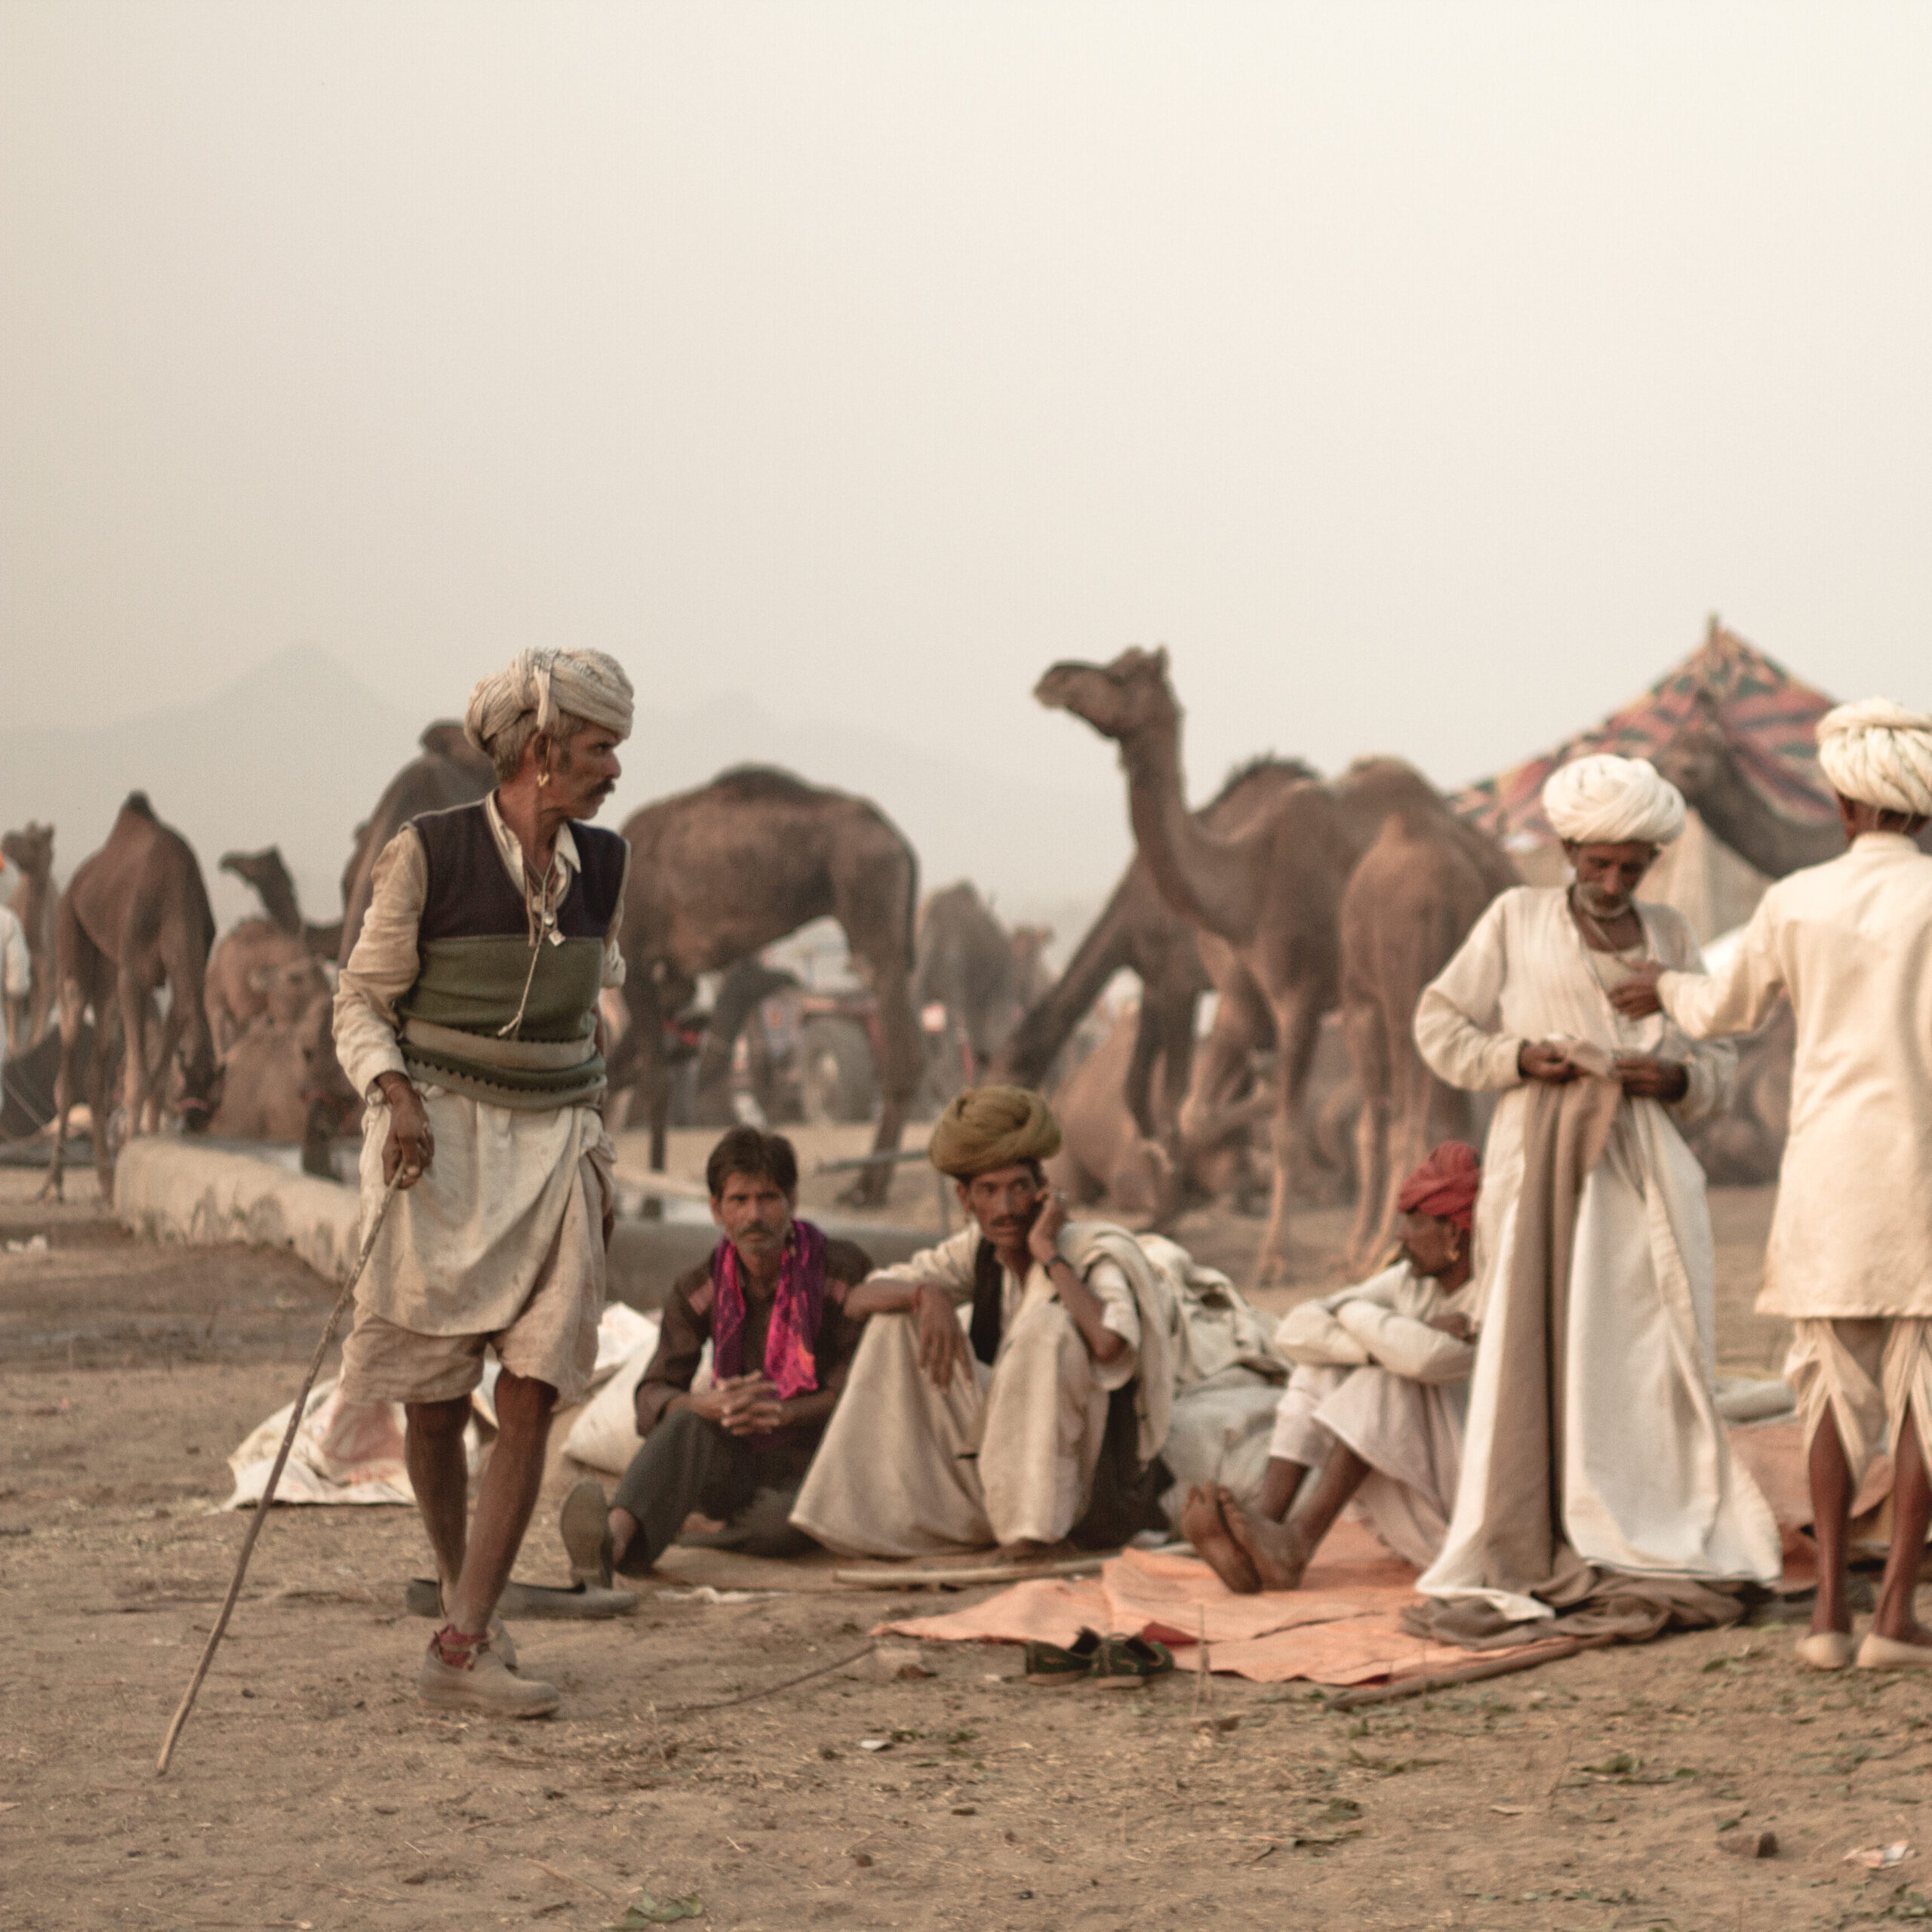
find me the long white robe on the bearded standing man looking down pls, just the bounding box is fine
[1416,887,1781,1619]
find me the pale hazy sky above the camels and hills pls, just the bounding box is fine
[0,0,1932,810]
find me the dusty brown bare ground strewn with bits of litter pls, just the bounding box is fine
[0,1174,1932,1932]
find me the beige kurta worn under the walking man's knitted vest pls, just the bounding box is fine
[336,794,624,1335]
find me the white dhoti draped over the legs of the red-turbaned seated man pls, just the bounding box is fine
[1269,1364,1469,1569]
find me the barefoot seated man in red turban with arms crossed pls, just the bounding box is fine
[1180,1140,1482,1592]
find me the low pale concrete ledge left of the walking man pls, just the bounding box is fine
[114,1134,361,1281]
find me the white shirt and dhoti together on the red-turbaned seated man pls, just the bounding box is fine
[1269,1262,1476,1569]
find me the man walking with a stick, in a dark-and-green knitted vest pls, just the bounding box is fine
[336,649,632,1718]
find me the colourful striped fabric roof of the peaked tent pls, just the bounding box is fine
[1449,618,1835,852]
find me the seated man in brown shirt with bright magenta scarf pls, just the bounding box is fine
[562,1126,872,1584]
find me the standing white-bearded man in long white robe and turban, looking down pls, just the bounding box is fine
[1416,755,1781,1631]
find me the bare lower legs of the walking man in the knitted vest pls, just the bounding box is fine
[404,1370,556,1632]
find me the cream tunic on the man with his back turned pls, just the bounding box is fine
[1657,832,1932,1318]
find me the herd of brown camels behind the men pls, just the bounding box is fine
[4,649,1838,1281]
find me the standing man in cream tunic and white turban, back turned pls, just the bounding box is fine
[1619,700,1932,1669]
